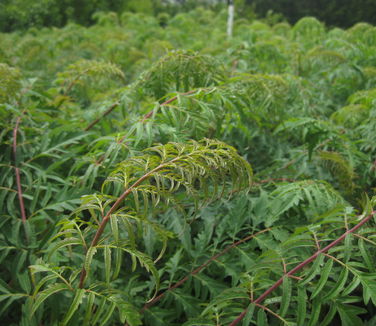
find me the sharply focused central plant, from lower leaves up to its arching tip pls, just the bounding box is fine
[33,139,252,319]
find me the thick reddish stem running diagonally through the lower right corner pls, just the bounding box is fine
[229,211,376,326]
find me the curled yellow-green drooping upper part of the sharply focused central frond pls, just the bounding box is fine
[103,139,252,211]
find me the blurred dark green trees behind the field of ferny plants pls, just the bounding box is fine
[0,0,376,32]
